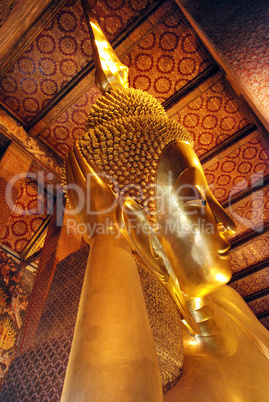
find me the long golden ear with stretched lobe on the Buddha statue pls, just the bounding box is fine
[118,197,200,335]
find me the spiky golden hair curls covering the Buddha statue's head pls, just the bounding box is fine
[79,88,192,225]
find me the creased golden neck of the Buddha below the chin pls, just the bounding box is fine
[184,296,237,356]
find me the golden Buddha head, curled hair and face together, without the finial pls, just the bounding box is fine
[70,89,235,297]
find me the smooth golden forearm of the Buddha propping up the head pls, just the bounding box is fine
[62,234,163,402]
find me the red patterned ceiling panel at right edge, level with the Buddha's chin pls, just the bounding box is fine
[230,268,269,300]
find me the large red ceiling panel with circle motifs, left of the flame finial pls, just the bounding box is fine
[0,0,91,123]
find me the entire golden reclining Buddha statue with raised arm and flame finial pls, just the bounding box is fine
[62,7,269,402]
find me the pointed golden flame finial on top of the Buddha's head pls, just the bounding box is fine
[82,0,129,92]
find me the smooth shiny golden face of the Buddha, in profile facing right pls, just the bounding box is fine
[156,142,235,297]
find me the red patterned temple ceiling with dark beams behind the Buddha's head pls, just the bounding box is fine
[0,0,269,325]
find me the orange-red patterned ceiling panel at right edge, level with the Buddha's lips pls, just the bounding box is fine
[230,232,269,273]
